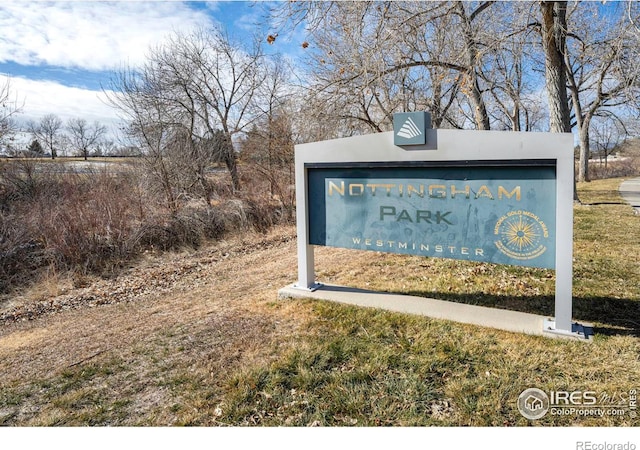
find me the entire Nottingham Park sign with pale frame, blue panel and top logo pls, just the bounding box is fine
[288,113,588,335]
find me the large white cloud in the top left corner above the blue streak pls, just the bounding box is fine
[0,1,218,70]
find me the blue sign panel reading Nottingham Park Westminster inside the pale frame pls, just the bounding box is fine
[308,164,556,269]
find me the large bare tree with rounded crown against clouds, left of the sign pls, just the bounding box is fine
[111,25,264,192]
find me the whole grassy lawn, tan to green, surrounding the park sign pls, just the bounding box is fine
[0,179,640,426]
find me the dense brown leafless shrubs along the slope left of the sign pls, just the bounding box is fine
[0,161,282,293]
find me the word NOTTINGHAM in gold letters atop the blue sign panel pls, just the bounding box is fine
[327,180,522,201]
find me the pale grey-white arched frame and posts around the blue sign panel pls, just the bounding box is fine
[294,129,580,336]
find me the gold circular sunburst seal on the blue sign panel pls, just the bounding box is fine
[494,210,549,260]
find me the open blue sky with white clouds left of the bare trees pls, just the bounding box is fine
[0,0,296,139]
